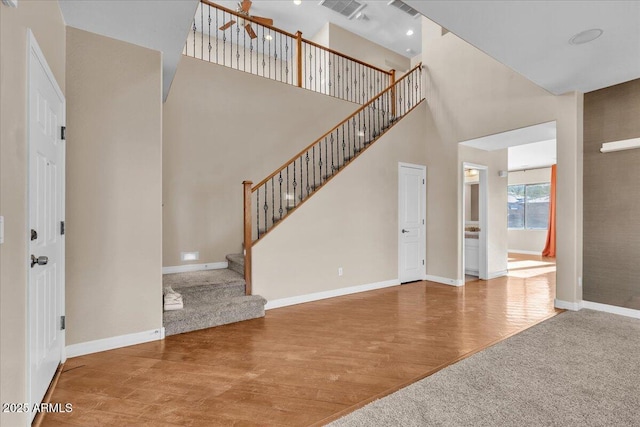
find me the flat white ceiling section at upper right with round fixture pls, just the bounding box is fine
[405,0,640,94]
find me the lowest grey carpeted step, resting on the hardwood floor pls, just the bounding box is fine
[163,295,267,335]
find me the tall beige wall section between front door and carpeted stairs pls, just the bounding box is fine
[66,28,162,345]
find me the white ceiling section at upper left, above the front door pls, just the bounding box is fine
[60,0,200,99]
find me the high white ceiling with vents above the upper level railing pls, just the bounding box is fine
[214,0,422,58]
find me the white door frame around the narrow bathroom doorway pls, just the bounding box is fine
[459,162,489,282]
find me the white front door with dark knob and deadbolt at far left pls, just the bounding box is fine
[26,29,65,417]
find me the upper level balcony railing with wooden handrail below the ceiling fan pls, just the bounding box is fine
[183,0,395,104]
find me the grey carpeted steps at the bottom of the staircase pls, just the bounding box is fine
[162,254,267,336]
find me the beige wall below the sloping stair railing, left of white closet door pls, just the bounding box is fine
[253,105,428,301]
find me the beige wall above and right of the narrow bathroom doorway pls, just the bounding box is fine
[460,145,508,277]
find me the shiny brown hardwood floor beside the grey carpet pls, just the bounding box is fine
[42,255,557,426]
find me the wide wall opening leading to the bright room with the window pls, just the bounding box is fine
[460,121,557,294]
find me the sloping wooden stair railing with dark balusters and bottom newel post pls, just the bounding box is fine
[243,64,424,294]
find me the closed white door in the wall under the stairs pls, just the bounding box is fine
[398,163,427,283]
